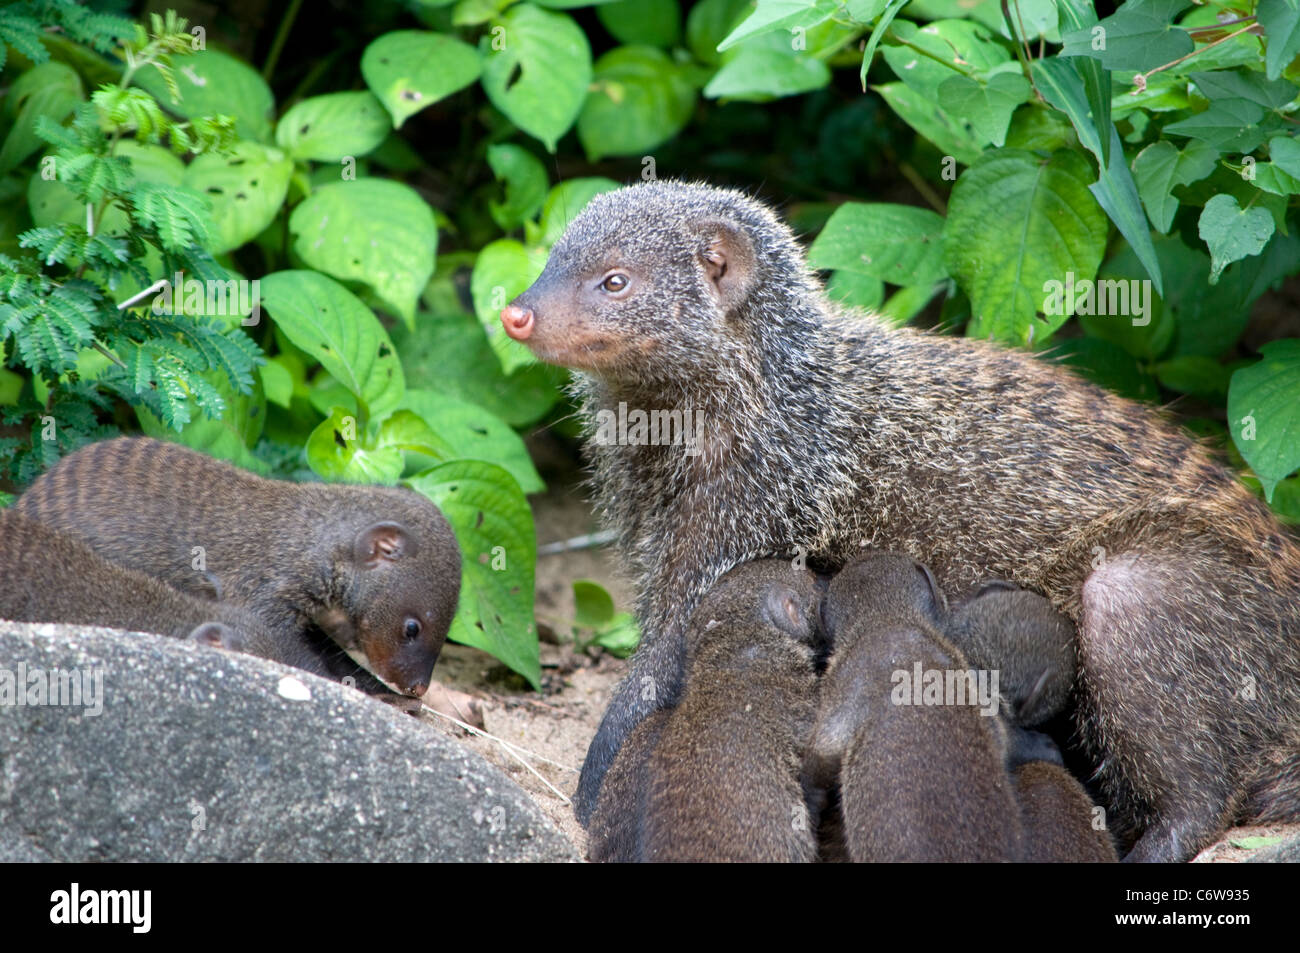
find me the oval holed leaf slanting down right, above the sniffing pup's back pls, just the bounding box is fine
[261,272,406,420]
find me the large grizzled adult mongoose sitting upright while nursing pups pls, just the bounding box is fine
[502,182,1300,861]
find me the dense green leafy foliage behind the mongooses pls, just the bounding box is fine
[0,0,1300,685]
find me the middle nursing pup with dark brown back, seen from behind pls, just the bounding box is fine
[807,554,1026,863]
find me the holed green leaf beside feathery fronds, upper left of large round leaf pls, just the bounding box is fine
[183,142,294,255]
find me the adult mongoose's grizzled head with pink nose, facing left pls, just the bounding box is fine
[502,181,815,381]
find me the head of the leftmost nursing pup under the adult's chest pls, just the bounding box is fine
[686,559,820,667]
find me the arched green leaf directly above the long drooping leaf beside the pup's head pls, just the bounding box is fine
[400,390,546,493]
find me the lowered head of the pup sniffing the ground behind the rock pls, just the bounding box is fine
[317,501,460,696]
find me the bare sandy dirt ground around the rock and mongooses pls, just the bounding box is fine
[410,488,1300,863]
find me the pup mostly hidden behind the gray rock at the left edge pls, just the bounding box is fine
[0,510,279,662]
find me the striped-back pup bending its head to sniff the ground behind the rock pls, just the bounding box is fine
[14,438,460,696]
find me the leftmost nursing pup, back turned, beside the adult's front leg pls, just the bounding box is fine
[589,559,819,862]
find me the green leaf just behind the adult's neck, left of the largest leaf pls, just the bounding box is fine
[809,202,948,285]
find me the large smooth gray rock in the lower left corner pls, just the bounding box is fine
[0,621,577,862]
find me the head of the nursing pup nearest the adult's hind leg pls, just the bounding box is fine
[946,580,1076,727]
